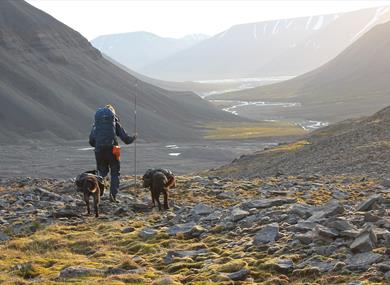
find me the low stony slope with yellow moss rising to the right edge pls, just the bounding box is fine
[208,103,390,178]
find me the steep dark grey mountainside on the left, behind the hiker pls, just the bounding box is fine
[0,0,237,144]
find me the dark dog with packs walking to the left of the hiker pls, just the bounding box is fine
[76,171,104,218]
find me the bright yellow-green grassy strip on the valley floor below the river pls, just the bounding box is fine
[204,121,307,140]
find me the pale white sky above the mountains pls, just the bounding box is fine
[26,0,390,40]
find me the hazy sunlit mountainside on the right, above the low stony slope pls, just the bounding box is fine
[212,19,390,122]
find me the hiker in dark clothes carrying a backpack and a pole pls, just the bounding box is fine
[89,105,137,203]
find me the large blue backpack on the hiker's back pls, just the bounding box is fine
[95,108,118,148]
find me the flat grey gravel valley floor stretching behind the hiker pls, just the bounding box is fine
[0,138,286,178]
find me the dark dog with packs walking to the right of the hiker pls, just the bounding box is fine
[142,169,176,211]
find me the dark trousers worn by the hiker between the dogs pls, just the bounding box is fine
[95,148,120,196]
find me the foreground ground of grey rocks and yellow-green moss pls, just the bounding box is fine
[0,176,390,285]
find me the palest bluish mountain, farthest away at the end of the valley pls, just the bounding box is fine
[91,32,208,71]
